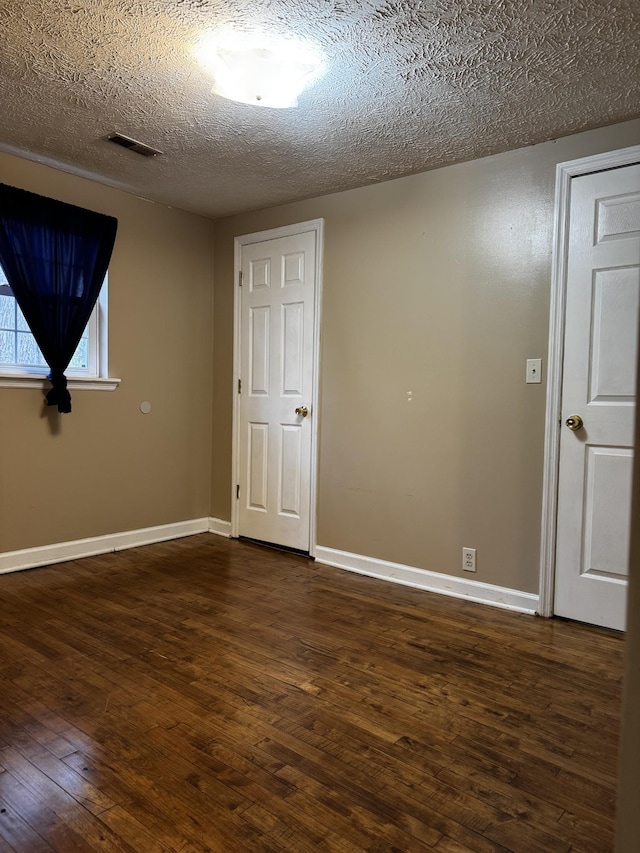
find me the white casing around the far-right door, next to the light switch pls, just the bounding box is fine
[538,145,640,616]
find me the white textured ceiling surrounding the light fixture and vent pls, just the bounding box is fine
[0,0,640,217]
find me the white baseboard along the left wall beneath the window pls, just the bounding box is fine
[0,518,211,574]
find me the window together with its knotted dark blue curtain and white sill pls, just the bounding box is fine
[0,183,118,402]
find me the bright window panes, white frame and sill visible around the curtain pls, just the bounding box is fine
[0,265,119,387]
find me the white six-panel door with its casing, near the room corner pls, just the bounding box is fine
[232,221,322,553]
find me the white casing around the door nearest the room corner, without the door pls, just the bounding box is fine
[231,219,324,557]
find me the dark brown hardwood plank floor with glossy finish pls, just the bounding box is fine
[0,534,623,853]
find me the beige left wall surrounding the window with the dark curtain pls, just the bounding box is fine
[0,155,213,551]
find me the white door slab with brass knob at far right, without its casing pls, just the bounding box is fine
[554,166,640,629]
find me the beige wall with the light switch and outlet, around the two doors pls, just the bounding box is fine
[212,116,640,592]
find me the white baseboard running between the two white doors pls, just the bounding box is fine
[315,545,538,613]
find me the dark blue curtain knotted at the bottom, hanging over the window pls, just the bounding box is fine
[0,184,118,412]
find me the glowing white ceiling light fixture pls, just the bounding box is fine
[196,29,323,109]
